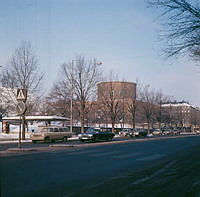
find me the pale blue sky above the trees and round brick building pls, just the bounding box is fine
[0,0,200,106]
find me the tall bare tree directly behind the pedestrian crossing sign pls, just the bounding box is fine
[2,42,44,139]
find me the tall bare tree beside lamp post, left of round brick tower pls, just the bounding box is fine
[61,56,101,132]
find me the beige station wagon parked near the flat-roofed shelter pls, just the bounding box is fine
[30,126,72,143]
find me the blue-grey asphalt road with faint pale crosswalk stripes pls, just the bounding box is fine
[0,136,200,197]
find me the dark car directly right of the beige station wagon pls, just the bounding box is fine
[78,130,115,142]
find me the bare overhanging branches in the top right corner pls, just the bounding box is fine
[149,0,200,60]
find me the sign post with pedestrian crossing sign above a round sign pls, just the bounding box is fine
[16,89,27,148]
